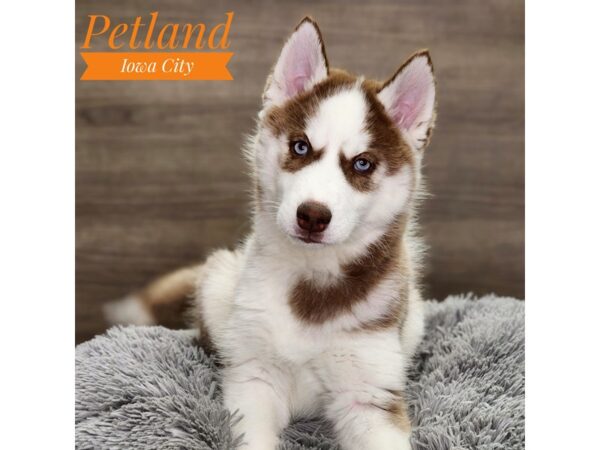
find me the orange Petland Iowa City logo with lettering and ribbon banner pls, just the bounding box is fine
[81,11,234,80]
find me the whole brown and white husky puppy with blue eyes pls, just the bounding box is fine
[106,18,435,450]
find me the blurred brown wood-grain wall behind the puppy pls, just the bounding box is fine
[76,0,524,342]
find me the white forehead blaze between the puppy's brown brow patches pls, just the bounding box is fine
[306,87,370,157]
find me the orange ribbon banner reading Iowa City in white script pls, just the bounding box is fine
[81,52,233,80]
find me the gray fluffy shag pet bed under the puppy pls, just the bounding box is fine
[75,296,525,450]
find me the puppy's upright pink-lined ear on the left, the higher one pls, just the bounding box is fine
[263,17,329,110]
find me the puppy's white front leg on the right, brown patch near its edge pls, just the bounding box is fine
[318,327,411,450]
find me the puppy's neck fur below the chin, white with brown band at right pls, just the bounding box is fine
[251,209,410,326]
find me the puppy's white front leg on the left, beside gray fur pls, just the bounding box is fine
[223,360,290,450]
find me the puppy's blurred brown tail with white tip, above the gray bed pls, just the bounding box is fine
[103,264,202,328]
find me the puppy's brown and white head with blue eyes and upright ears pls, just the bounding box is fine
[250,18,435,245]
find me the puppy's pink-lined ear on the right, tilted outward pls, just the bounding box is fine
[377,50,435,149]
